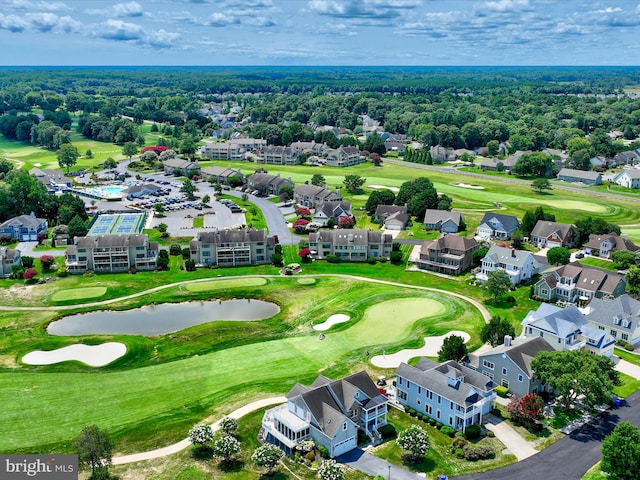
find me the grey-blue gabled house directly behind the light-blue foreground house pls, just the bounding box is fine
[468,335,554,397]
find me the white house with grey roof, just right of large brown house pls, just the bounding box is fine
[476,245,540,285]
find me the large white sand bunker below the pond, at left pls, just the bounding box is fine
[22,342,127,367]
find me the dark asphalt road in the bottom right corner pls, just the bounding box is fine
[455,391,640,480]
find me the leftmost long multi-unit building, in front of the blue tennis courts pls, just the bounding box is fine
[65,234,159,273]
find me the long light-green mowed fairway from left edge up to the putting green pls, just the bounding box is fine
[0,294,470,451]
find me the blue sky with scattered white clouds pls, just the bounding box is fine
[0,0,640,65]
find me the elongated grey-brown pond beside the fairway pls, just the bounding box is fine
[47,298,280,337]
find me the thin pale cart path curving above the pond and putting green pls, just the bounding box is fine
[0,273,491,323]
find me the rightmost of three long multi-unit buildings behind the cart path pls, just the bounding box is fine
[309,229,393,262]
